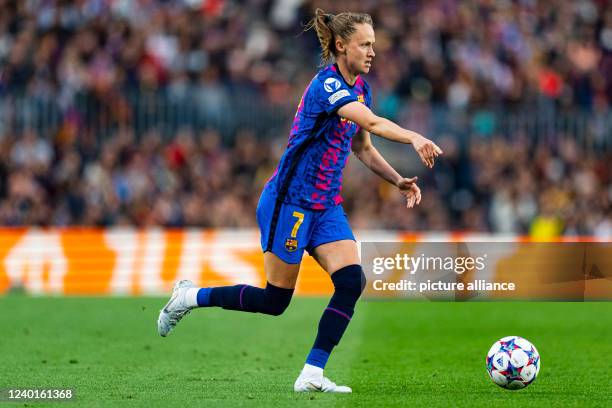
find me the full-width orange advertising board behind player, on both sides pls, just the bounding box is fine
[0,228,612,298]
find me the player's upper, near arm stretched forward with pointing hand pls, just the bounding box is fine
[338,102,442,168]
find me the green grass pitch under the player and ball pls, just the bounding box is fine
[0,295,612,408]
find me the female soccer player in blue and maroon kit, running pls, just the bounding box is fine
[157,9,442,392]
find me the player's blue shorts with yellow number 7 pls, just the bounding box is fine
[257,188,355,264]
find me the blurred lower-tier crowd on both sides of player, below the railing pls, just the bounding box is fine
[0,126,612,239]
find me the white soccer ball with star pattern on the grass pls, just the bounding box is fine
[487,336,540,390]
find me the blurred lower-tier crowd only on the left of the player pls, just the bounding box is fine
[0,130,276,227]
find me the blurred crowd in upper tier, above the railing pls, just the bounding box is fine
[0,0,612,111]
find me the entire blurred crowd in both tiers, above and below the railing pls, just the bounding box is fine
[0,0,612,238]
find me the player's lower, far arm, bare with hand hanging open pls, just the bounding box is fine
[352,129,421,208]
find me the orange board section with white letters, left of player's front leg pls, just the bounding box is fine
[0,228,332,295]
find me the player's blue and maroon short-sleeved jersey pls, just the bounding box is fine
[266,64,372,210]
